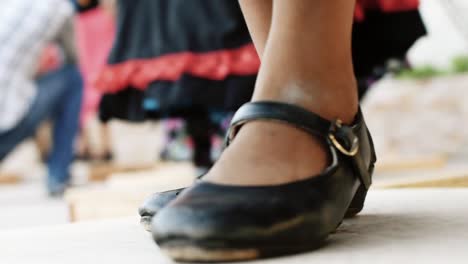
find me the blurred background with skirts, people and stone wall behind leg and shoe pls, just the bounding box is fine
[0,0,468,230]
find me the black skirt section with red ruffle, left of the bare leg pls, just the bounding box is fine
[100,0,259,121]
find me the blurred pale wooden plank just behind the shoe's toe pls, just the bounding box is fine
[65,163,195,221]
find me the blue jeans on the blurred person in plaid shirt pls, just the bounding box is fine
[0,65,83,189]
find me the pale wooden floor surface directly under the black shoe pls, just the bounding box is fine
[0,189,468,264]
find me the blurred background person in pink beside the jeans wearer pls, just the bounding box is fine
[73,0,115,160]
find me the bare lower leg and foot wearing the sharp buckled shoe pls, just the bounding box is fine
[204,0,358,185]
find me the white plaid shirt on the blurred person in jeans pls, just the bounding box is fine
[0,0,73,132]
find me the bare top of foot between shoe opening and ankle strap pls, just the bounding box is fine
[203,97,355,186]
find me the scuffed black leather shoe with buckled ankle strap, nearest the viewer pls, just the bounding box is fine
[152,102,376,261]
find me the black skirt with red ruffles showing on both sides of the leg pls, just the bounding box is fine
[96,0,425,121]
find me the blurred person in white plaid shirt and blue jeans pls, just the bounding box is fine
[0,0,82,196]
